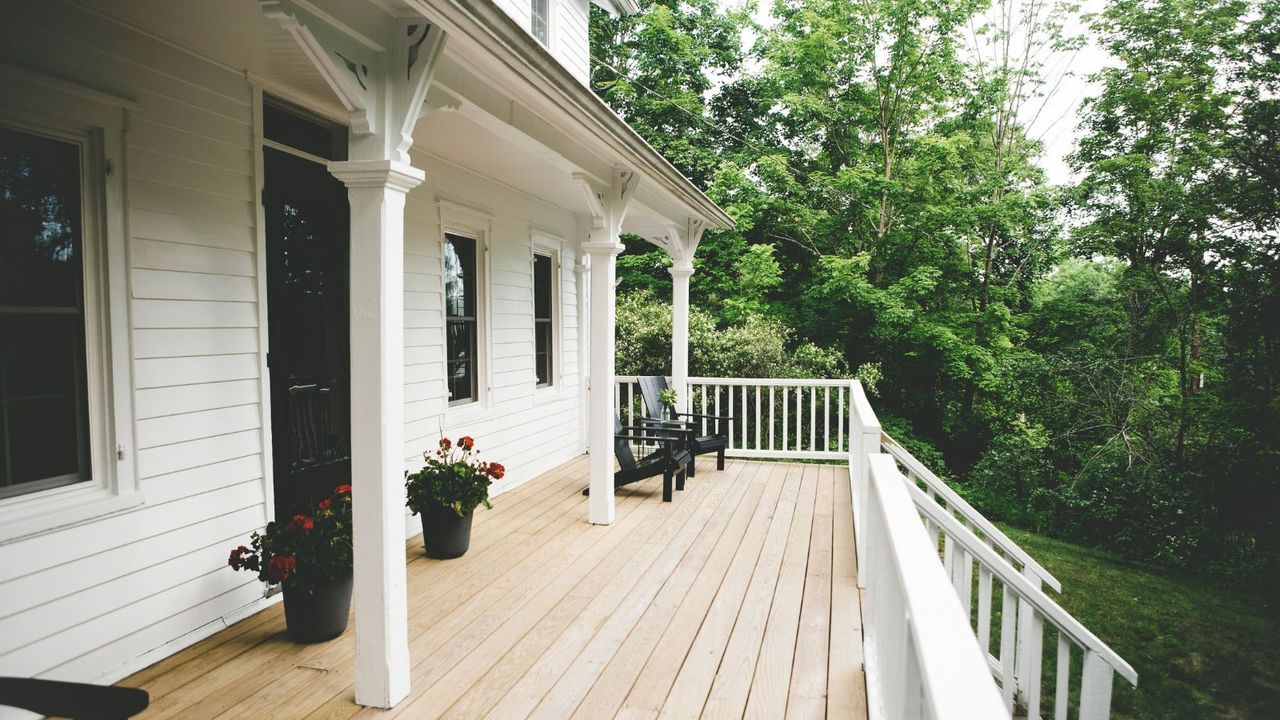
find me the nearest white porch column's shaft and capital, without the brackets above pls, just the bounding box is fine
[329,160,425,707]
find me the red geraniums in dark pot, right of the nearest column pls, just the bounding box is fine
[404,437,507,560]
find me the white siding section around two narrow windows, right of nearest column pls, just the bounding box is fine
[404,155,581,489]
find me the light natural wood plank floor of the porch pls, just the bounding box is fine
[122,459,867,720]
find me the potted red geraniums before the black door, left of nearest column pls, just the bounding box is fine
[227,486,351,643]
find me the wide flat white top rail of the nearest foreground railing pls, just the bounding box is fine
[869,454,1007,719]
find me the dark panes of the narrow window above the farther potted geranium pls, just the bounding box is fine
[444,233,480,405]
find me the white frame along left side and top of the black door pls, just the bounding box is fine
[248,85,349,524]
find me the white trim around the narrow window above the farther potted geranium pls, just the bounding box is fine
[436,199,493,424]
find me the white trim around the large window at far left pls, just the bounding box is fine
[0,64,145,544]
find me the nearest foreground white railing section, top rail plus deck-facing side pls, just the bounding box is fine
[859,454,1009,720]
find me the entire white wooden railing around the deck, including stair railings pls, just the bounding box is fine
[616,375,1138,720]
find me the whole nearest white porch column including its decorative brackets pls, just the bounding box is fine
[259,0,445,707]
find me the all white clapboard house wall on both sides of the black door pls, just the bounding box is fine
[0,3,585,680]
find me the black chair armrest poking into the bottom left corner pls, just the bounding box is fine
[0,678,151,720]
